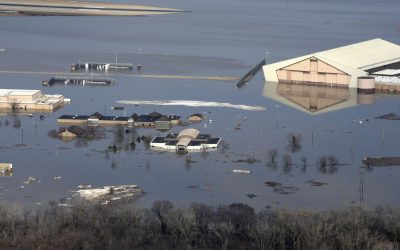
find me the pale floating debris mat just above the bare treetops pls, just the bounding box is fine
[76,185,143,205]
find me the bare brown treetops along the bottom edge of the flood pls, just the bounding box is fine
[0,201,400,250]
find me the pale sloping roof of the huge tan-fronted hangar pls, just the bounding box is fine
[263,38,400,87]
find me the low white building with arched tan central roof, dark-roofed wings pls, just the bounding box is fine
[150,128,222,153]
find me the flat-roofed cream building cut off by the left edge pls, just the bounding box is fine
[0,89,69,111]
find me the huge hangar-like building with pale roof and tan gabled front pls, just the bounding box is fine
[263,38,400,88]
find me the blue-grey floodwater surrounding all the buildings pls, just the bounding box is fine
[0,0,400,209]
